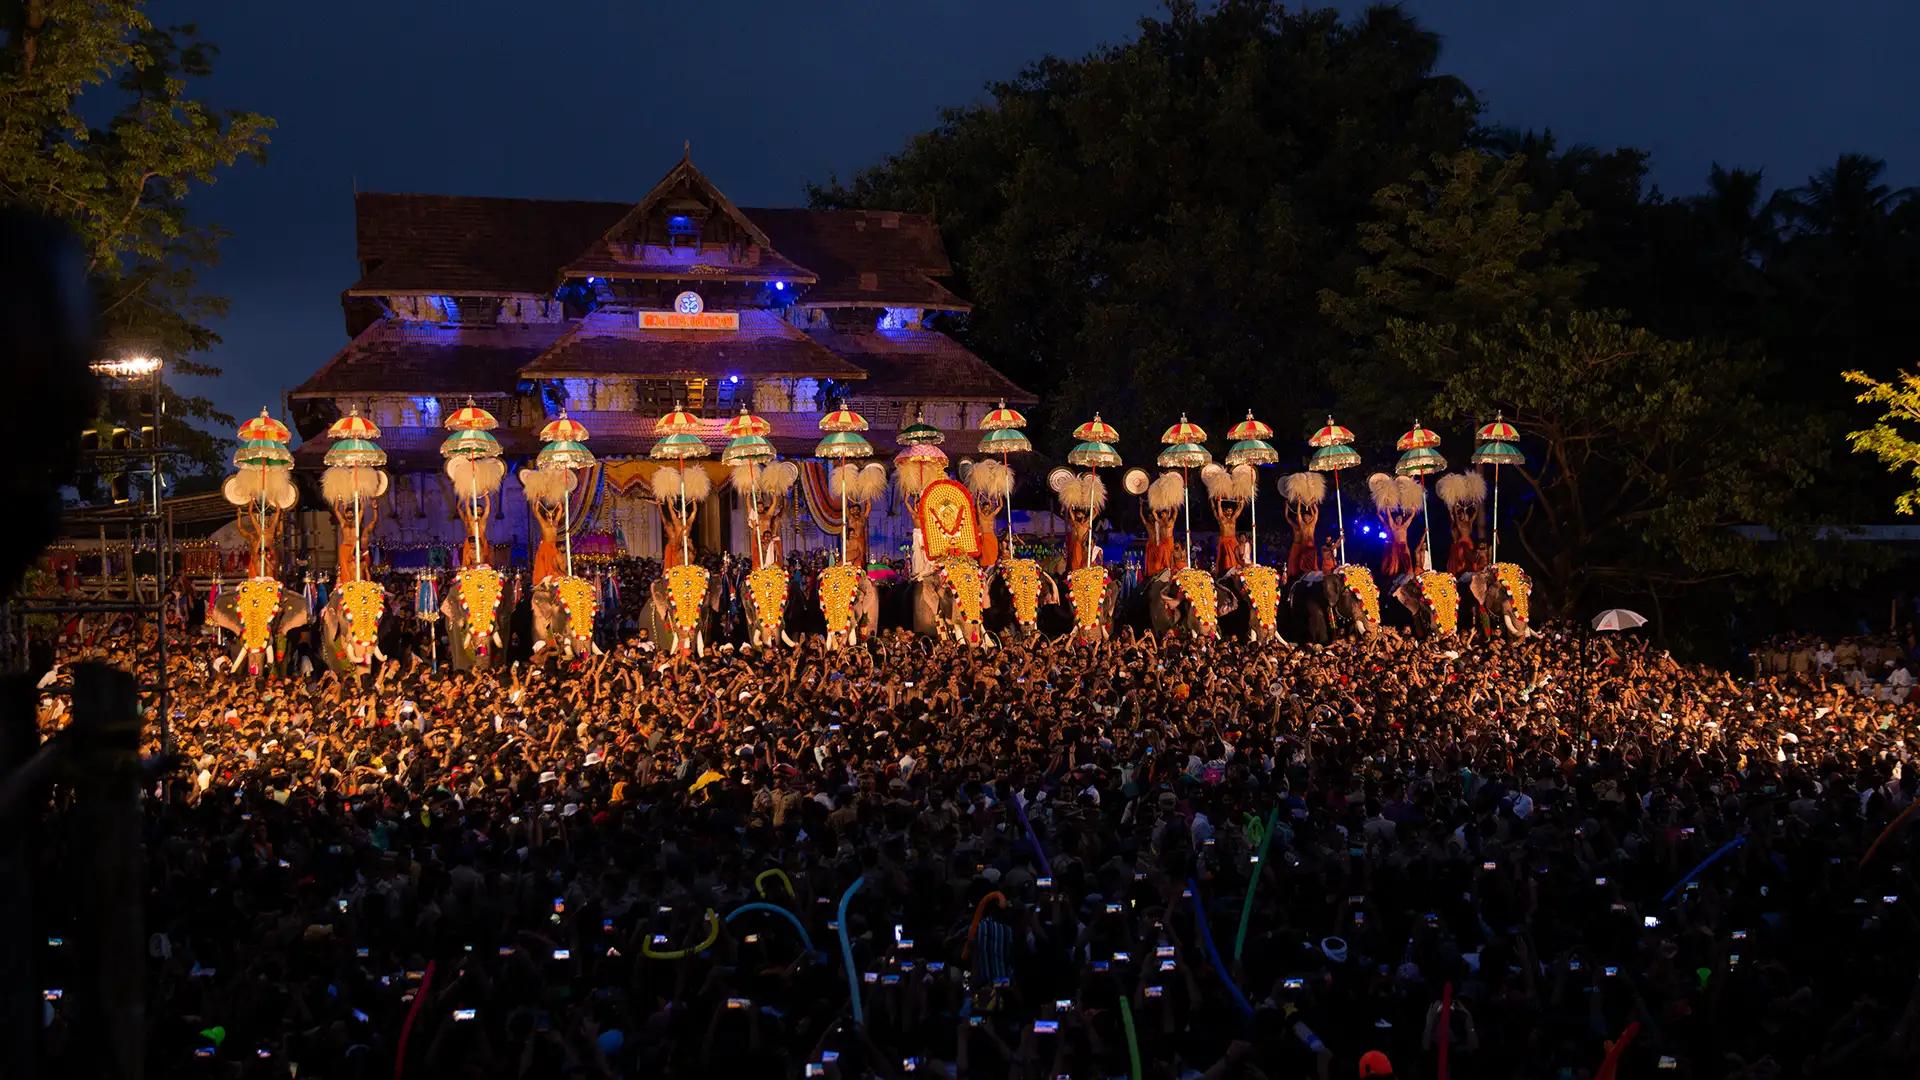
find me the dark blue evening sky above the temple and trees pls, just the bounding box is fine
[168,0,1920,428]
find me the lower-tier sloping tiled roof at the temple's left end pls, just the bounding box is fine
[292,319,566,398]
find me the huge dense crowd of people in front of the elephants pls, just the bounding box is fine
[26,595,1920,1080]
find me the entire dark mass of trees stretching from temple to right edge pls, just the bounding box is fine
[812,0,1920,622]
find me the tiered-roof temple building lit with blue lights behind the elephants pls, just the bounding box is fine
[292,158,1033,569]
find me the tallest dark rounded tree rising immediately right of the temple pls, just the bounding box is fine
[814,0,1478,459]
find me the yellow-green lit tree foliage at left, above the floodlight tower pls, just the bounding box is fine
[0,0,273,467]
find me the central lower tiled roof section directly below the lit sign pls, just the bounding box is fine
[520,309,866,379]
